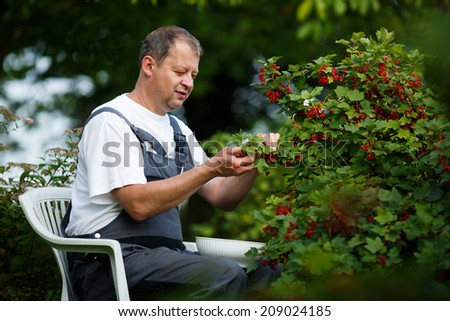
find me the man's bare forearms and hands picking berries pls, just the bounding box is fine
[111,147,257,220]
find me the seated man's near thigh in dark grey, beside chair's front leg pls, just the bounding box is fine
[122,244,247,300]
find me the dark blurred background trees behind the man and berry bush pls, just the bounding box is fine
[0,0,450,139]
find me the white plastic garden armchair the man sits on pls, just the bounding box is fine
[19,187,130,301]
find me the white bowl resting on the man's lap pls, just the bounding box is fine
[195,236,266,268]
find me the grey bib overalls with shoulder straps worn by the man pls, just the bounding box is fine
[63,107,280,300]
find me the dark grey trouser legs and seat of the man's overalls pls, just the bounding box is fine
[71,243,281,301]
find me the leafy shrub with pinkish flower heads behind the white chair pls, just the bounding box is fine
[0,107,79,300]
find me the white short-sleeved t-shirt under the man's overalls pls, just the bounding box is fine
[66,94,207,235]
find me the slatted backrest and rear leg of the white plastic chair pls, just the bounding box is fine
[19,187,76,300]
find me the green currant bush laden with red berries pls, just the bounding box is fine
[244,28,450,298]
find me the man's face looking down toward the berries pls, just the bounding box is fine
[150,41,200,114]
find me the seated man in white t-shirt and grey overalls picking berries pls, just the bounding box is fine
[65,26,278,300]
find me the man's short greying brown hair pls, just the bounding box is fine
[139,26,203,65]
